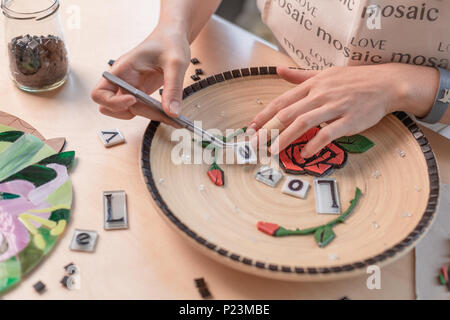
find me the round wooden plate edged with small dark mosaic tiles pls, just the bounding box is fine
[141,67,439,281]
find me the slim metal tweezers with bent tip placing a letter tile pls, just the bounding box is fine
[103,71,235,148]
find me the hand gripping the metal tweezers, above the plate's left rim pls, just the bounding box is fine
[91,28,190,125]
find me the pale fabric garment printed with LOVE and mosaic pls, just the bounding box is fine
[257,0,450,70]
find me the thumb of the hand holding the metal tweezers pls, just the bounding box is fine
[162,62,187,117]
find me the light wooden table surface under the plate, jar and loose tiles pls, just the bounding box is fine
[0,0,450,299]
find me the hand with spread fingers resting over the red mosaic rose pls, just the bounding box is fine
[249,63,439,158]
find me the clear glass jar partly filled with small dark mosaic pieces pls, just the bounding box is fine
[1,0,69,92]
